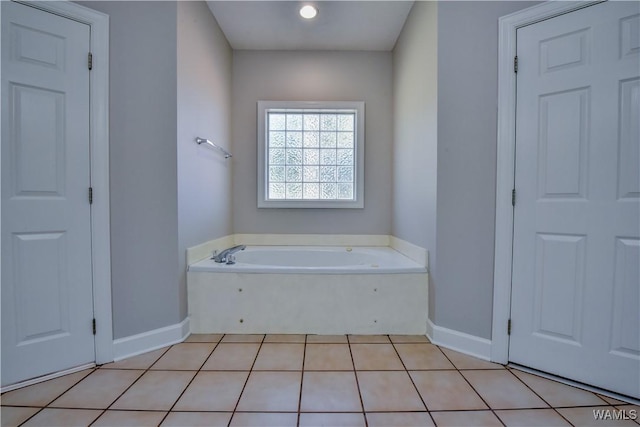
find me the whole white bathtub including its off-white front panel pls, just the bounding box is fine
[187,246,428,334]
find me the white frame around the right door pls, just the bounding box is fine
[491,0,604,364]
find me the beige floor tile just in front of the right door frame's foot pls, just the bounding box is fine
[461,369,548,409]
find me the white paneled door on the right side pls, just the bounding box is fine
[509,2,640,398]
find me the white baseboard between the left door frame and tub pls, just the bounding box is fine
[113,317,189,362]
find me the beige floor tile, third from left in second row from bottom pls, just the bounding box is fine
[110,371,196,411]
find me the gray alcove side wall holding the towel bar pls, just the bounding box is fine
[177,1,235,319]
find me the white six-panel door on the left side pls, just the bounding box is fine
[0,1,95,385]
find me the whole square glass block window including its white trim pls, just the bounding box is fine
[258,102,364,208]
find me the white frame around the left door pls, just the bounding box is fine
[0,0,113,364]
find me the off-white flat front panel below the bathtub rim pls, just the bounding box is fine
[187,271,427,335]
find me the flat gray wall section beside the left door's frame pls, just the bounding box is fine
[81,1,182,339]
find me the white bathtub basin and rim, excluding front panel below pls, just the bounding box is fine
[189,246,426,274]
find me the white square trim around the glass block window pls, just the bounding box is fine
[257,101,365,209]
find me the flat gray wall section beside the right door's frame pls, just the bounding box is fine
[430,1,536,338]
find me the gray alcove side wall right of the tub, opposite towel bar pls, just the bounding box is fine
[392,2,439,320]
